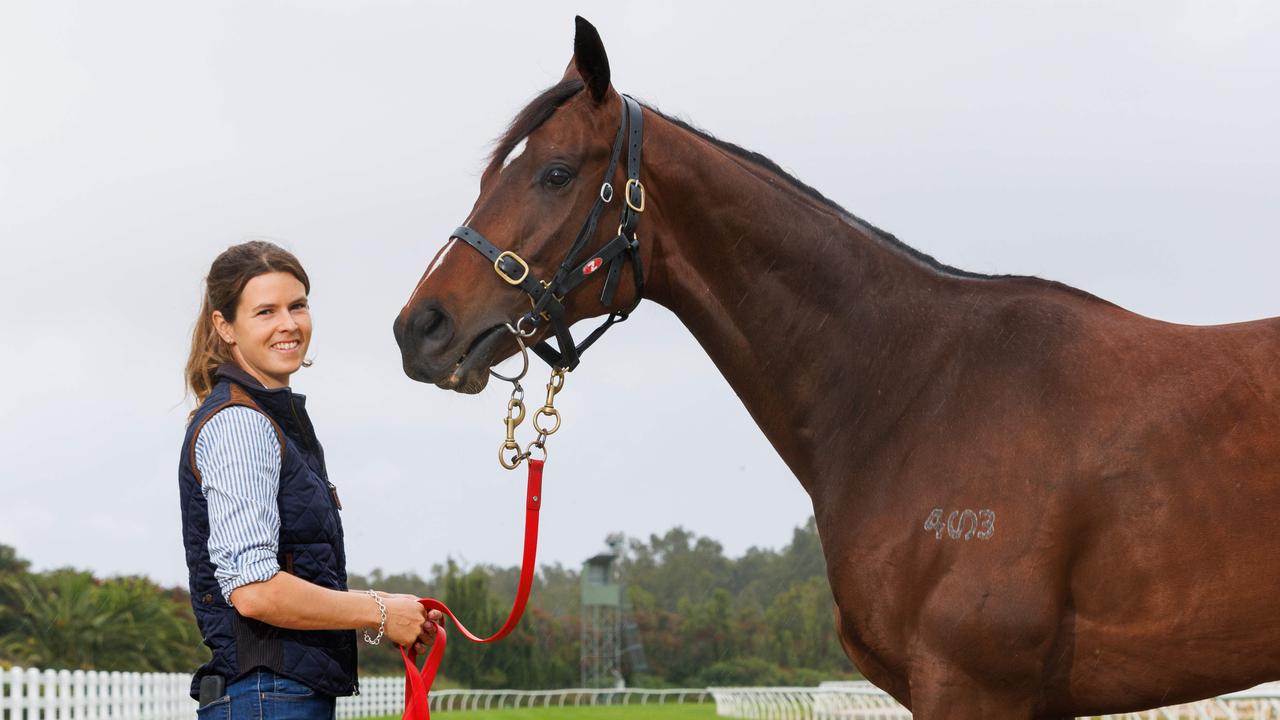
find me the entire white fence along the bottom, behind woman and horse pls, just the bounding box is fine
[0,667,1280,720]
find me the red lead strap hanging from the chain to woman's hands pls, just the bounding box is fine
[399,459,543,720]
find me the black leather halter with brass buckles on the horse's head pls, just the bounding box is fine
[452,95,644,370]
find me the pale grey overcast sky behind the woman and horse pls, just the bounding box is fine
[0,0,1280,584]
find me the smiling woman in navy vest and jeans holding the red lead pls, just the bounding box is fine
[178,242,440,720]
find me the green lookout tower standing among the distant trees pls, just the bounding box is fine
[581,536,649,688]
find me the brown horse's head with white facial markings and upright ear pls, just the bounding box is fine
[394,18,644,393]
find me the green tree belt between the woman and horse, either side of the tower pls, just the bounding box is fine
[351,519,854,688]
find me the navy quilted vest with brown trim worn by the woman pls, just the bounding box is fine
[178,365,360,697]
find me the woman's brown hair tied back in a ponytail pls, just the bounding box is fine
[186,240,311,405]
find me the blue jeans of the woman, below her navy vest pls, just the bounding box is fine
[196,670,335,720]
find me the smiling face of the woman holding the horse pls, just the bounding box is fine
[214,273,311,388]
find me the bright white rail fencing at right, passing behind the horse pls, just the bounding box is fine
[709,683,1280,720]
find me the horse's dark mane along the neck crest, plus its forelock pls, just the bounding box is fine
[485,78,1098,300]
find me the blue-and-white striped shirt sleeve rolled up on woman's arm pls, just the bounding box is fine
[196,405,280,603]
